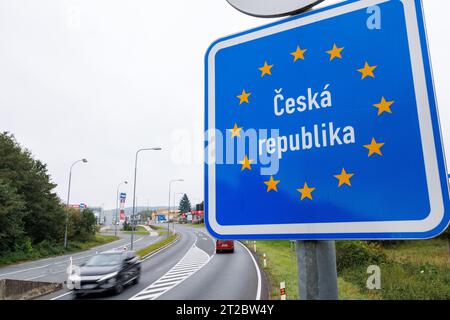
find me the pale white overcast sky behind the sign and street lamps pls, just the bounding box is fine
[0,0,450,208]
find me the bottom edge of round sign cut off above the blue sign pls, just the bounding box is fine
[227,0,324,18]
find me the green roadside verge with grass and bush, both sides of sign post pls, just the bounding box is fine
[244,239,450,300]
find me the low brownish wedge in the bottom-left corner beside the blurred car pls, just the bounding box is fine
[0,279,63,300]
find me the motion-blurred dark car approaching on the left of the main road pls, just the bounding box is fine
[69,251,141,296]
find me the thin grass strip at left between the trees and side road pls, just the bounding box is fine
[0,234,119,266]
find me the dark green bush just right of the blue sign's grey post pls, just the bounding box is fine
[336,241,387,272]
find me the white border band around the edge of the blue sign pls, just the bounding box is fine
[207,0,444,236]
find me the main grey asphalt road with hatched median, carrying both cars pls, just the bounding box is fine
[41,225,267,300]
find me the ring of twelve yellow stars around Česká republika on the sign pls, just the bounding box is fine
[228,43,395,201]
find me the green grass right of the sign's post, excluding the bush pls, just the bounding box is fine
[342,239,450,300]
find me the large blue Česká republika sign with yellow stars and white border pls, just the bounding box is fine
[205,0,449,240]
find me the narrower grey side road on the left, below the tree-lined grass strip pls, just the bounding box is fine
[0,233,160,282]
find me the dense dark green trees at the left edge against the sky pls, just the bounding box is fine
[0,132,96,257]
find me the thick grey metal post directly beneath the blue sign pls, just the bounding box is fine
[297,240,338,300]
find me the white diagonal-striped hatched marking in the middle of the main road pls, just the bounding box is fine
[130,240,212,300]
